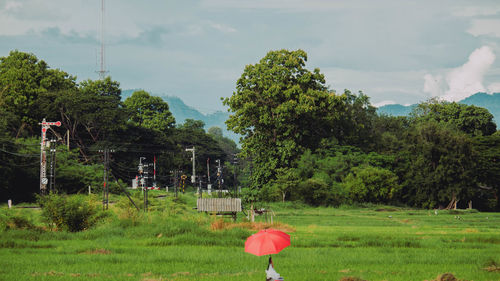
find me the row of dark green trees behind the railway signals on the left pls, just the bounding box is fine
[0,51,238,202]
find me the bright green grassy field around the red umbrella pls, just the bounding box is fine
[0,192,500,281]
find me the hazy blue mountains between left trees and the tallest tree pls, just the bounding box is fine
[122,89,240,143]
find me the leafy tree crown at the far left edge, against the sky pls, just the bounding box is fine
[0,51,76,137]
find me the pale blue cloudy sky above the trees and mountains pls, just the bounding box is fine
[0,0,500,113]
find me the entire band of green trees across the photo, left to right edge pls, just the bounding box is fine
[0,50,500,210]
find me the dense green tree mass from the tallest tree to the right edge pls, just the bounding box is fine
[223,50,500,210]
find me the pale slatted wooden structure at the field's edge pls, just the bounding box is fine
[196,198,241,220]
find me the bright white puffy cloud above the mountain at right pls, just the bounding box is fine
[424,46,497,101]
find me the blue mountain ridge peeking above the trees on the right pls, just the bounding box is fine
[377,93,500,122]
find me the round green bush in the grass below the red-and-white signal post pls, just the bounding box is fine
[38,194,105,232]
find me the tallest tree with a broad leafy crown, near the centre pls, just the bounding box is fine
[223,50,337,187]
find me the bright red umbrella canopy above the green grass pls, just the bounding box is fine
[245,229,290,256]
